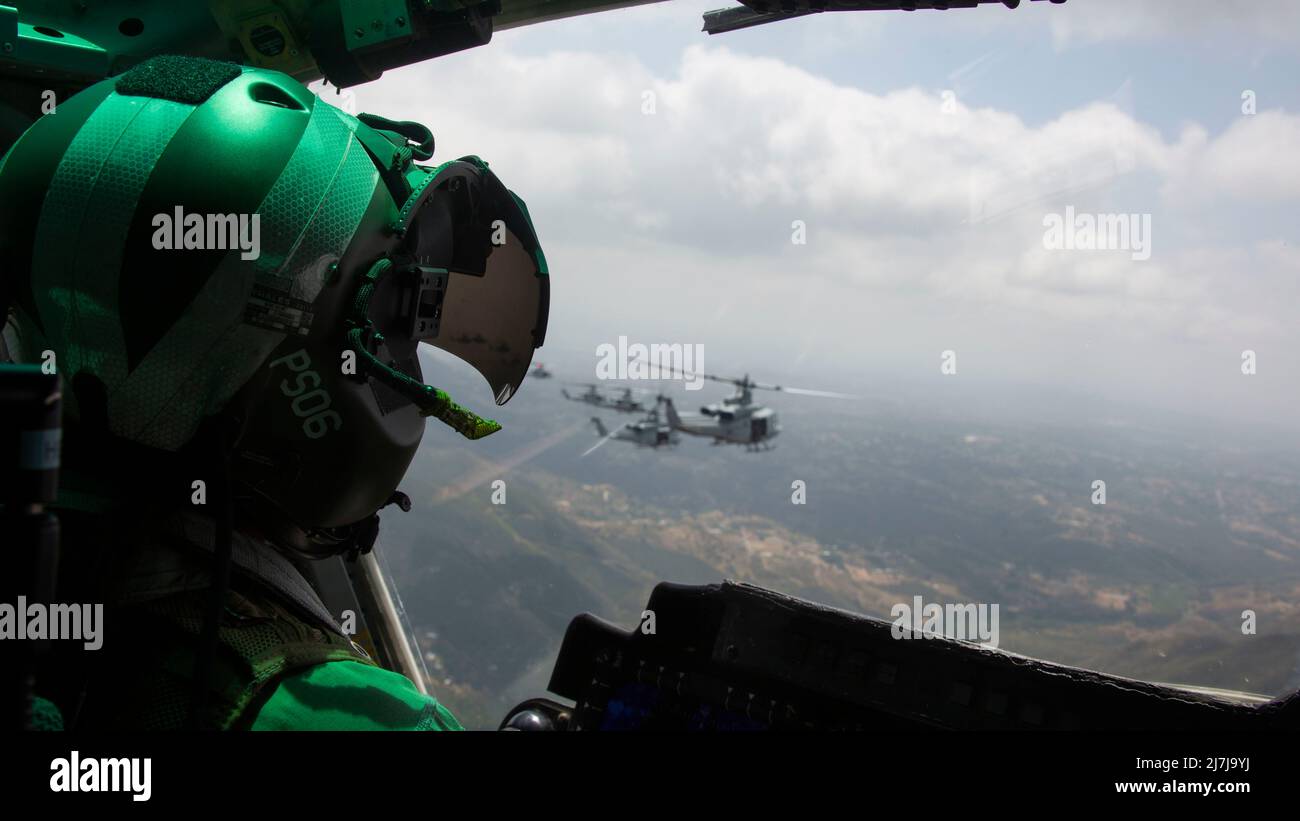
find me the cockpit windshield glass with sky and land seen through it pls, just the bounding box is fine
[322,0,1300,726]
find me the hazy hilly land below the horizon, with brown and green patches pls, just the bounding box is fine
[380,355,1300,726]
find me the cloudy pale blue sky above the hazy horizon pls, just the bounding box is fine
[321,0,1300,433]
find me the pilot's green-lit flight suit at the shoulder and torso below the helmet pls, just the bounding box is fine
[48,513,463,731]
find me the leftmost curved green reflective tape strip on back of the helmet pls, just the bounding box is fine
[33,95,194,423]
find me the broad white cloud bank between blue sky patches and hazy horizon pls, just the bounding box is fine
[335,34,1300,423]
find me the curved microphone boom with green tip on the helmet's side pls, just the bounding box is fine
[347,257,501,439]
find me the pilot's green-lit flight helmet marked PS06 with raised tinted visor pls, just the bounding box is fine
[0,57,549,547]
